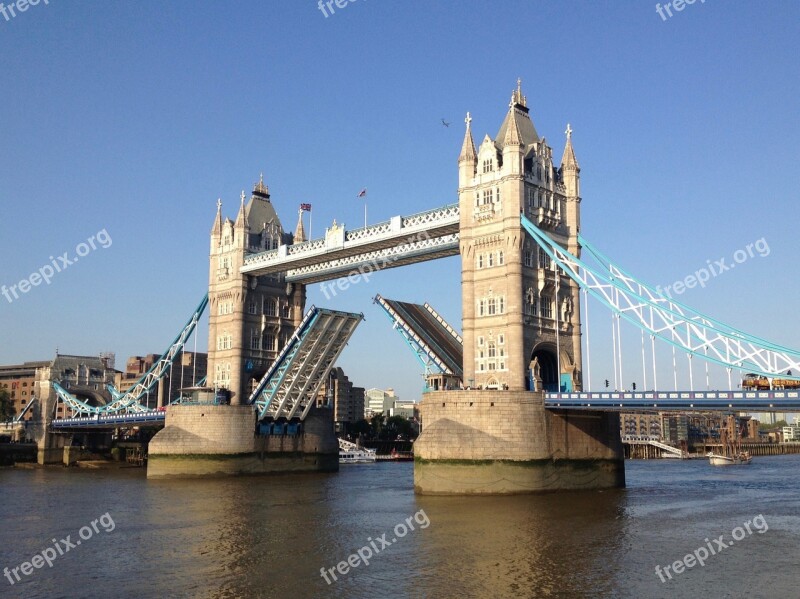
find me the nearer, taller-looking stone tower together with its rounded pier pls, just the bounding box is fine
[414,82,625,495]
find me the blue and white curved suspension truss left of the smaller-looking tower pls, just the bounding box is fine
[52,294,208,417]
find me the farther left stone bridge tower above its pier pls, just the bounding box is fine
[206,177,306,404]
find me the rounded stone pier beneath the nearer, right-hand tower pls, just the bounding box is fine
[414,390,625,495]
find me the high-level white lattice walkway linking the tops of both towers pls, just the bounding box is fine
[240,204,459,284]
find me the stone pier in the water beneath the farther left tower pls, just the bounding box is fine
[147,405,339,478]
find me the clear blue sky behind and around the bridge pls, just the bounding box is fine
[0,0,800,406]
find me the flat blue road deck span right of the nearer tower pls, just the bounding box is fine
[544,391,800,412]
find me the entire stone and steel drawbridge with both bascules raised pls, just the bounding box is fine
[28,81,800,494]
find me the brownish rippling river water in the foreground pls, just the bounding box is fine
[0,455,800,599]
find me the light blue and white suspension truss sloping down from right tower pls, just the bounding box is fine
[520,215,800,380]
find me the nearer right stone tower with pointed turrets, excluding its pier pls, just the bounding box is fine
[458,81,582,391]
